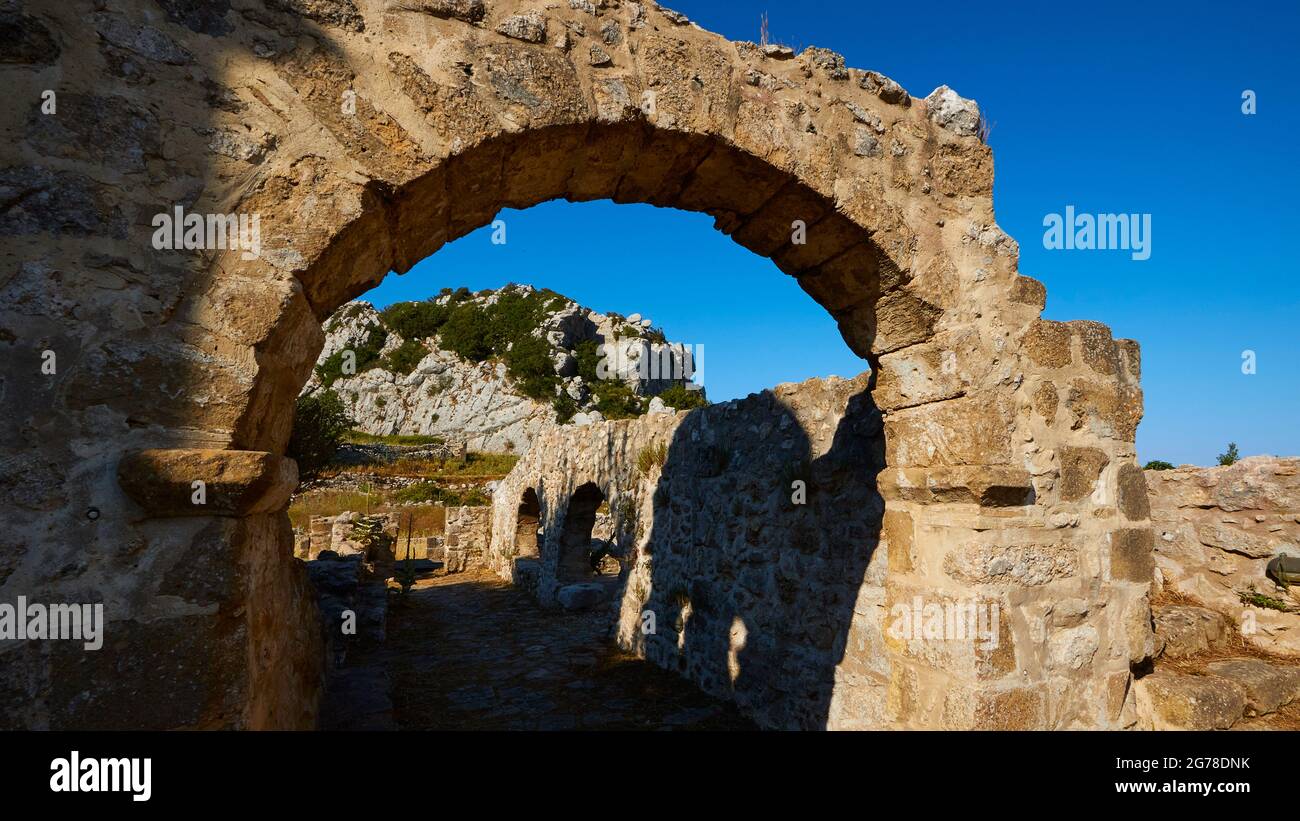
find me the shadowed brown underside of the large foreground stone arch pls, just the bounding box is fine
[231,117,925,452]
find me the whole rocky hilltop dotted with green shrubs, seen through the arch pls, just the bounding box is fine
[303,286,703,451]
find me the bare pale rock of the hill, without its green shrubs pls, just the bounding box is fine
[303,286,694,451]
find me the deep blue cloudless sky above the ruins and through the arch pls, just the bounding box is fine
[365,0,1300,464]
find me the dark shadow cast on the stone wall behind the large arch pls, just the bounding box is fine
[629,379,887,729]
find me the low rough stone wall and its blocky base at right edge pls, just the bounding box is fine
[1134,456,1300,730]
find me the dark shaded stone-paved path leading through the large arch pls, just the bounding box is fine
[324,572,754,730]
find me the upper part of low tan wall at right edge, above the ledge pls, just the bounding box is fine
[1145,456,1300,656]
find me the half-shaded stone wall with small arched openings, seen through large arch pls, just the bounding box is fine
[489,377,888,729]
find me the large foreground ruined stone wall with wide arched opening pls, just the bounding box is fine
[0,0,1151,727]
